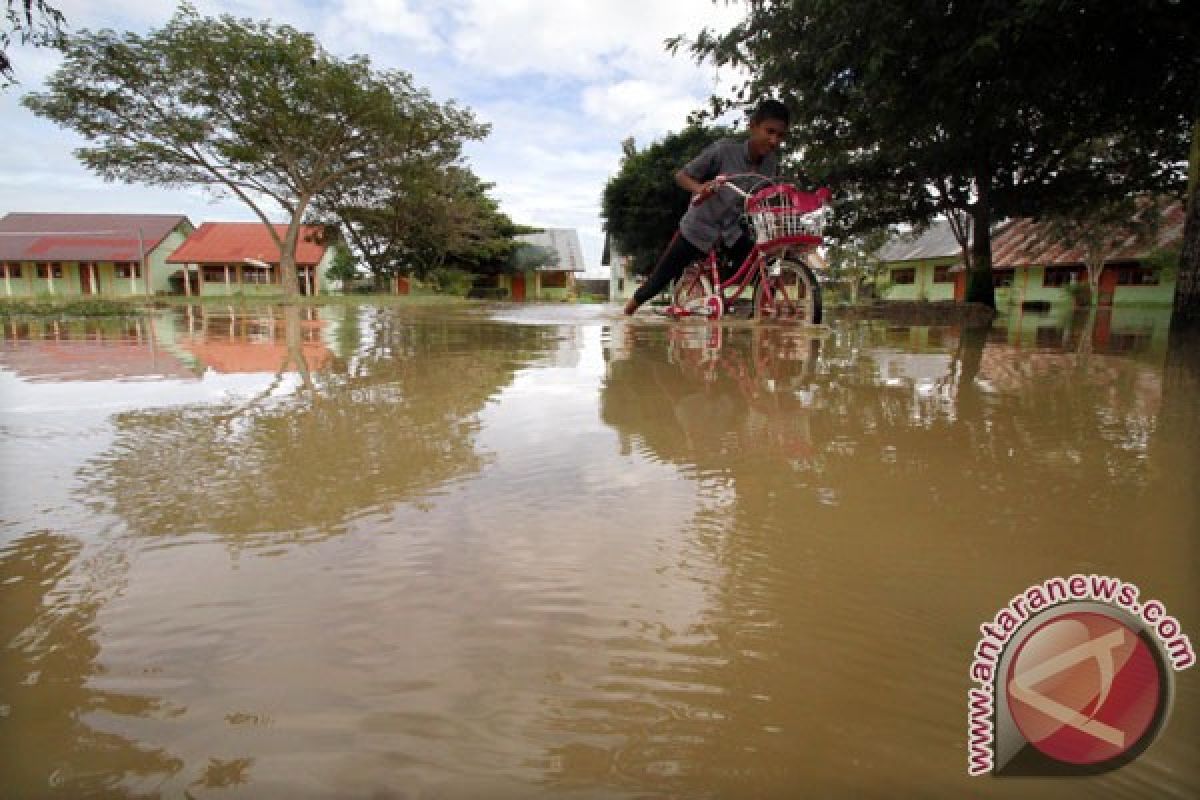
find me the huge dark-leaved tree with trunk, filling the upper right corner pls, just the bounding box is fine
[671,0,1198,305]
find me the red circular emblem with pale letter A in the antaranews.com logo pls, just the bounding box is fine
[1004,612,1163,764]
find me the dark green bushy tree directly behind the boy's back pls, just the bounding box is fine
[600,125,731,275]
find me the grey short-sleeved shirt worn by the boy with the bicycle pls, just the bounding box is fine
[679,139,779,252]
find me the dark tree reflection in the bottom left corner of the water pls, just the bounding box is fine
[0,531,182,798]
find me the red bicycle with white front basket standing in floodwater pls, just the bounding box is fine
[665,173,829,325]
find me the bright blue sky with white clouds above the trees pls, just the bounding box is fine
[0,0,744,275]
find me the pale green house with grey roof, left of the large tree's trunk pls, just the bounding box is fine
[876,219,965,301]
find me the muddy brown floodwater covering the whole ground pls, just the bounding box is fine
[0,306,1200,798]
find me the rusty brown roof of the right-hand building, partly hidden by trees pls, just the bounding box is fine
[991,203,1184,269]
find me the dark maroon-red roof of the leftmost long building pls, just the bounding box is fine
[0,212,192,261]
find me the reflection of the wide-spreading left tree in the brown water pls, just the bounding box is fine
[85,308,541,543]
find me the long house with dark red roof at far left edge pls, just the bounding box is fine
[0,212,192,297]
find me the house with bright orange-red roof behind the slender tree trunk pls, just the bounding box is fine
[167,222,334,296]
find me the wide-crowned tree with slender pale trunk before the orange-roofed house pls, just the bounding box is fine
[23,4,487,295]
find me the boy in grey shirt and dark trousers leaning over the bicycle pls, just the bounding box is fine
[625,100,791,314]
